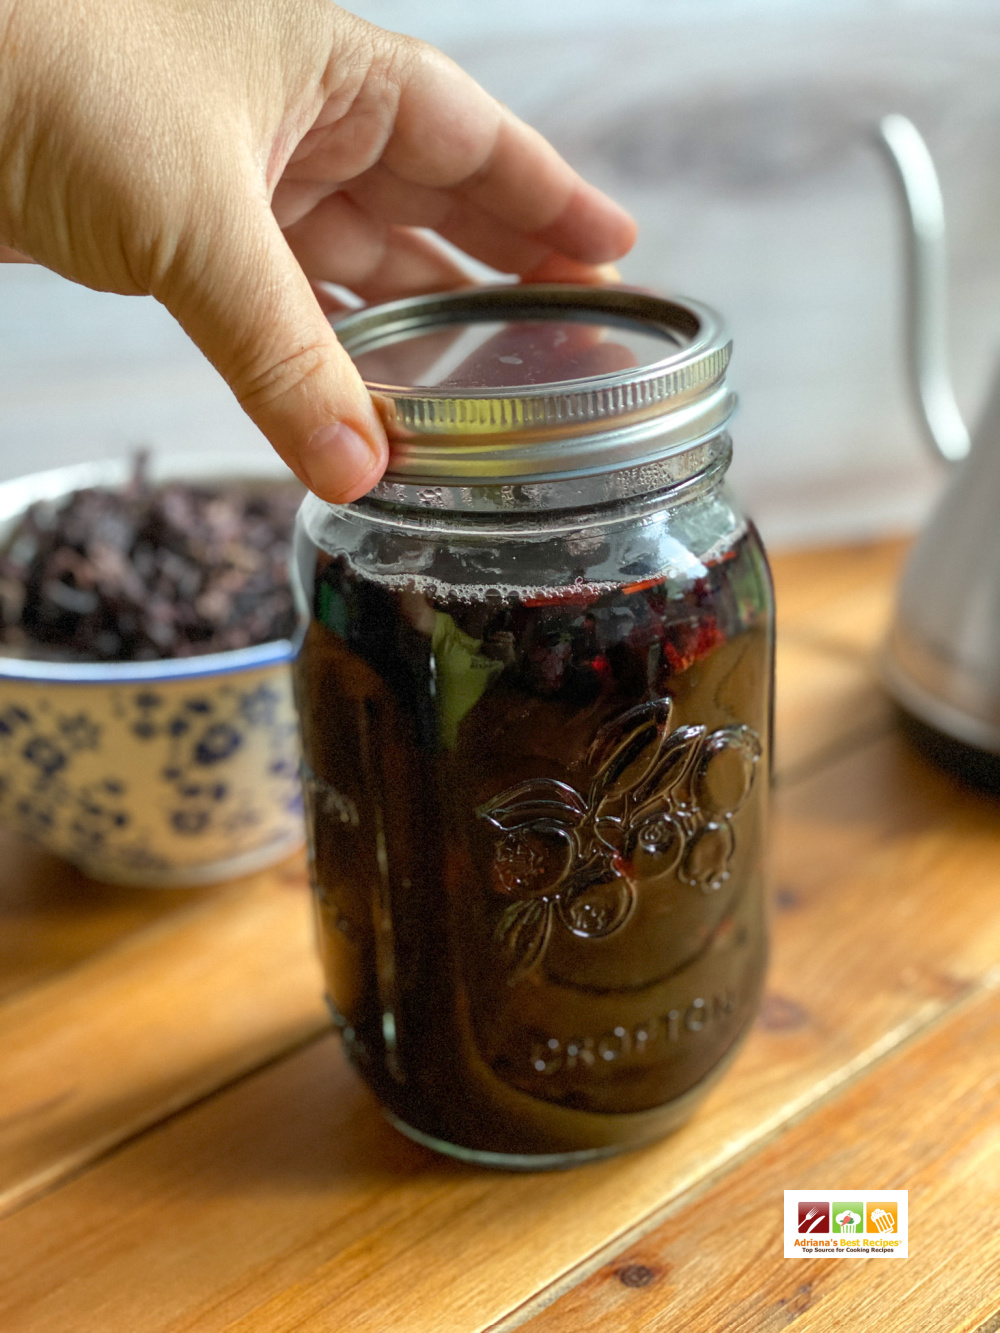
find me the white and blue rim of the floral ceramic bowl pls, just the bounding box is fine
[0,451,301,685]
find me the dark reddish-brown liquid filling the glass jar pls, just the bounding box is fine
[297,533,771,1156]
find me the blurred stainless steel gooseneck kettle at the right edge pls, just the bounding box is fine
[879,116,1000,785]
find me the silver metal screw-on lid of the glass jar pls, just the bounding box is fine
[335,283,736,508]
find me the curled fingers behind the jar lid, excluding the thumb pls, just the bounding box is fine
[284,35,636,281]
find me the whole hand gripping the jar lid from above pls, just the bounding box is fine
[0,0,635,501]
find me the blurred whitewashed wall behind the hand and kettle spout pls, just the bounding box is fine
[0,0,1000,544]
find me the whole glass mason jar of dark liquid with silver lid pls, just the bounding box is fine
[289,285,772,1168]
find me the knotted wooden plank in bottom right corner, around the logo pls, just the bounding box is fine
[504,977,1000,1333]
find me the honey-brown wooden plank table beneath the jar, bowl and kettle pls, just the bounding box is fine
[0,544,1000,1333]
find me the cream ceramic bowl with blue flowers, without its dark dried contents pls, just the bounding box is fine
[0,455,304,888]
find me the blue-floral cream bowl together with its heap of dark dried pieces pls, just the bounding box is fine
[0,455,303,888]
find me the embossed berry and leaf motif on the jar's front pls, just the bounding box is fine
[476,698,761,982]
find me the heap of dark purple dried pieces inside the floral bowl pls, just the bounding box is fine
[0,456,300,661]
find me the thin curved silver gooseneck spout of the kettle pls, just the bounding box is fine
[879,115,969,463]
